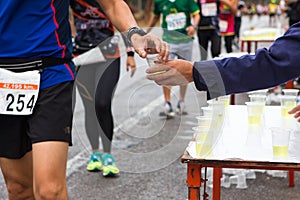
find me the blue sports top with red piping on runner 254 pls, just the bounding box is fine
[0,0,75,88]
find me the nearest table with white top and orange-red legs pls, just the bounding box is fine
[181,105,300,200]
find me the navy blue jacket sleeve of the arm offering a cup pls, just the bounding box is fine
[193,22,300,98]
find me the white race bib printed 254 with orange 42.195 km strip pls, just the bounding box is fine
[0,68,40,115]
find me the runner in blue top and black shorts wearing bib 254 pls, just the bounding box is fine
[0,0,169,200]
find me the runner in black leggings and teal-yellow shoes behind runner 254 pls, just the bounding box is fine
[70,0,136,176]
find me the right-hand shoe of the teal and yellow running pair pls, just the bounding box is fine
[102,153,120,177]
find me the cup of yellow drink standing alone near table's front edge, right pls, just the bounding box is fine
[270,127,291,158]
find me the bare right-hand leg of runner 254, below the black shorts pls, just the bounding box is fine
[32,141,69,200]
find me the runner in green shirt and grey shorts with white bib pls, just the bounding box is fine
[147,0,200,119]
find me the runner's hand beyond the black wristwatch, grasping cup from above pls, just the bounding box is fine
[131,33,170,61]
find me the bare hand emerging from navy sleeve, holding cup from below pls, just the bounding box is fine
[146,59,193,86]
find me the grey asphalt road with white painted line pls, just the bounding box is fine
[0,14,300,200]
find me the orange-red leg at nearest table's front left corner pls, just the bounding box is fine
[186,163,201,200]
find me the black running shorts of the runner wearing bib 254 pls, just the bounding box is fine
[0,81,74,159]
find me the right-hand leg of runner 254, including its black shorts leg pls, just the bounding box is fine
[28,81,73,200]
